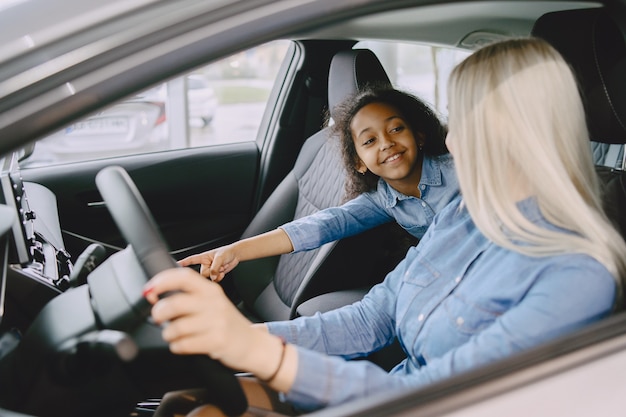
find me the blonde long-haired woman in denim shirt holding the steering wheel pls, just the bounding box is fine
[146,39,626,414]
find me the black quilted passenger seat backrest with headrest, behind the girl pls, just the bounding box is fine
[230,49,390,321]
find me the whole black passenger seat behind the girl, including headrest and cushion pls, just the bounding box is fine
[226,49,414,321]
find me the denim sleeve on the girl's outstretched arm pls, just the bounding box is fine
[280,193,393,252]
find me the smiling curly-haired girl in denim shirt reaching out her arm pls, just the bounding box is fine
[179,87,458,281]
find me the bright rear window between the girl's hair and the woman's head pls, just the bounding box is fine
[355,41,473,117]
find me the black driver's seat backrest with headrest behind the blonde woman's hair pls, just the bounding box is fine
[532,8,626,286]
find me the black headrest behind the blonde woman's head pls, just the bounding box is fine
[532,8,626,143]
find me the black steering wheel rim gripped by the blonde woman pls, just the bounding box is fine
[95,166,248,415]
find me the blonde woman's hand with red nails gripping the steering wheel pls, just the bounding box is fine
[144,268,283,378]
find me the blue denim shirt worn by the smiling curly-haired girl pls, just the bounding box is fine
[281,154,459,252]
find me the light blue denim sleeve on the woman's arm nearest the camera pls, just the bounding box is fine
[270,256,616,410]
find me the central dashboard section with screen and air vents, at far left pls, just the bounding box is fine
[0,153,73,332]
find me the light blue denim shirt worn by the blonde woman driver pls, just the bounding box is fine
[268,198,616,410]
